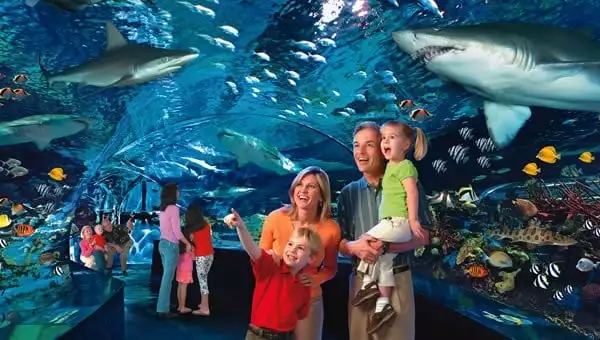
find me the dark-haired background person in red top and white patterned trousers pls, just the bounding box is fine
[184,203,215,316]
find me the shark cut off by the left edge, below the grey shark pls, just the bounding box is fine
[0,114,94,150]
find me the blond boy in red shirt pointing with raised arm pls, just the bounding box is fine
[224,209,321,340]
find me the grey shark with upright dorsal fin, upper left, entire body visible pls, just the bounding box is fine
[40,22,198,87]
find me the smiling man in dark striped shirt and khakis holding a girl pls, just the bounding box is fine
[338,122,430,340]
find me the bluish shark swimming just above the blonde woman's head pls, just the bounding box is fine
[217,129,298,175]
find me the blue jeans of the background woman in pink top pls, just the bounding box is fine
[156,239,179,313]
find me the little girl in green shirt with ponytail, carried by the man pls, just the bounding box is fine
[352,121,427,334]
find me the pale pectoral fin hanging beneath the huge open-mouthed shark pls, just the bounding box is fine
[483,101,531,149]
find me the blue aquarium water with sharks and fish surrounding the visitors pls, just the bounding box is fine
[0,0,600,337]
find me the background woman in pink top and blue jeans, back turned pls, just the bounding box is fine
[156,183,192,318]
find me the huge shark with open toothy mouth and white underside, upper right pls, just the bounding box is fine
[392,23,600,148]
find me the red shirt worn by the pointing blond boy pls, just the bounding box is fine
[250,249,310,332]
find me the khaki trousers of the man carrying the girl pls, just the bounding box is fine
[348,270,415,340]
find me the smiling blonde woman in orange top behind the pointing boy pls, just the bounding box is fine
[260,166,341,340]
